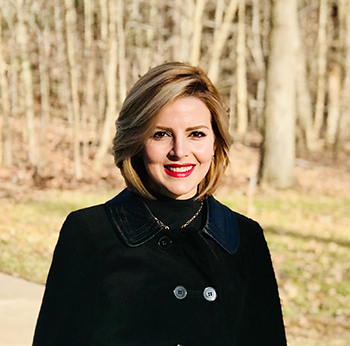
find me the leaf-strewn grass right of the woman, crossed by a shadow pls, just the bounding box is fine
[221,187,350,346]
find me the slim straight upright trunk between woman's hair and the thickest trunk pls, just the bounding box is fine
[236,0,248,138]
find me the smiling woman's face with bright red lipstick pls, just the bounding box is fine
[143,97,215,199]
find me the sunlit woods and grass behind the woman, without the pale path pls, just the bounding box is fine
[0,0,350,346]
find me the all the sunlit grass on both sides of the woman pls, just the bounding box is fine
[0,188,350,346]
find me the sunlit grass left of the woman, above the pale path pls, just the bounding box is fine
[0,190,117,283]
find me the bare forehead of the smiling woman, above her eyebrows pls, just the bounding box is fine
[153,96,211,125]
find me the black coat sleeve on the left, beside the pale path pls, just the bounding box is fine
[33,212,98,346]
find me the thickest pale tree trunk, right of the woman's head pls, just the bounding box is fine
[260,0,298,188]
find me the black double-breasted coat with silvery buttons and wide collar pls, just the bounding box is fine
[33,189,286,346]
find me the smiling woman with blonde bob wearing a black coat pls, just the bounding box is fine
[33,63,286,346]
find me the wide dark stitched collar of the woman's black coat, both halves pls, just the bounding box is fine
[105,189,240,254]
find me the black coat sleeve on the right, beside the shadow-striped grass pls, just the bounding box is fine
[237,223,287,346]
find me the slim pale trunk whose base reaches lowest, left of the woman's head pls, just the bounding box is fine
[65,0,83,180]
